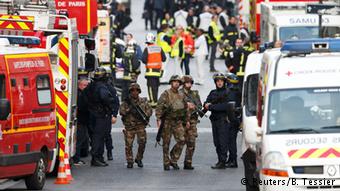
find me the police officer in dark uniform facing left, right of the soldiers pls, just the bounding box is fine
[204,73,229,169]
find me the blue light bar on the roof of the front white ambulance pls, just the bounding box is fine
[281,38,340,55]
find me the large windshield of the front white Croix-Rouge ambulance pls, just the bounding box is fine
[268,87,340,134]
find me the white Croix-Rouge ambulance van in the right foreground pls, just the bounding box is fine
[254,39,340,191]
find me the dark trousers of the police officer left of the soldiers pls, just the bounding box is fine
[91,115,112,161]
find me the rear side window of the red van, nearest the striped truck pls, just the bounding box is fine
[37,75,52,105]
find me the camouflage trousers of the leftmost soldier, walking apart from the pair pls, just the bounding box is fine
[124,126,147,163]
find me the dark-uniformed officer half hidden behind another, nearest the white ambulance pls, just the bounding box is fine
[226,73,242,168]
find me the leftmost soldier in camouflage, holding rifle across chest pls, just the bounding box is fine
[120,83,152,168]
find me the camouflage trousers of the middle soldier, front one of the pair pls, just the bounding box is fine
[162,119,185,166]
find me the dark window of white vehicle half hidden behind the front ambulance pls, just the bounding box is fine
[244,74,259,116]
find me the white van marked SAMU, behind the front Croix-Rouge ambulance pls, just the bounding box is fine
[261,2,340,42]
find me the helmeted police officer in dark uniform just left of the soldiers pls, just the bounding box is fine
[88,67,119,166]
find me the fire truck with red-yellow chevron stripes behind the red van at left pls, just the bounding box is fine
[0,1,85,179]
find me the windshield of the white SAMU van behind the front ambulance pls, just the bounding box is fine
[279,26,340,41]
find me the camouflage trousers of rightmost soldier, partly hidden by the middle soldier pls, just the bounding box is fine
[184,119,197,164]
